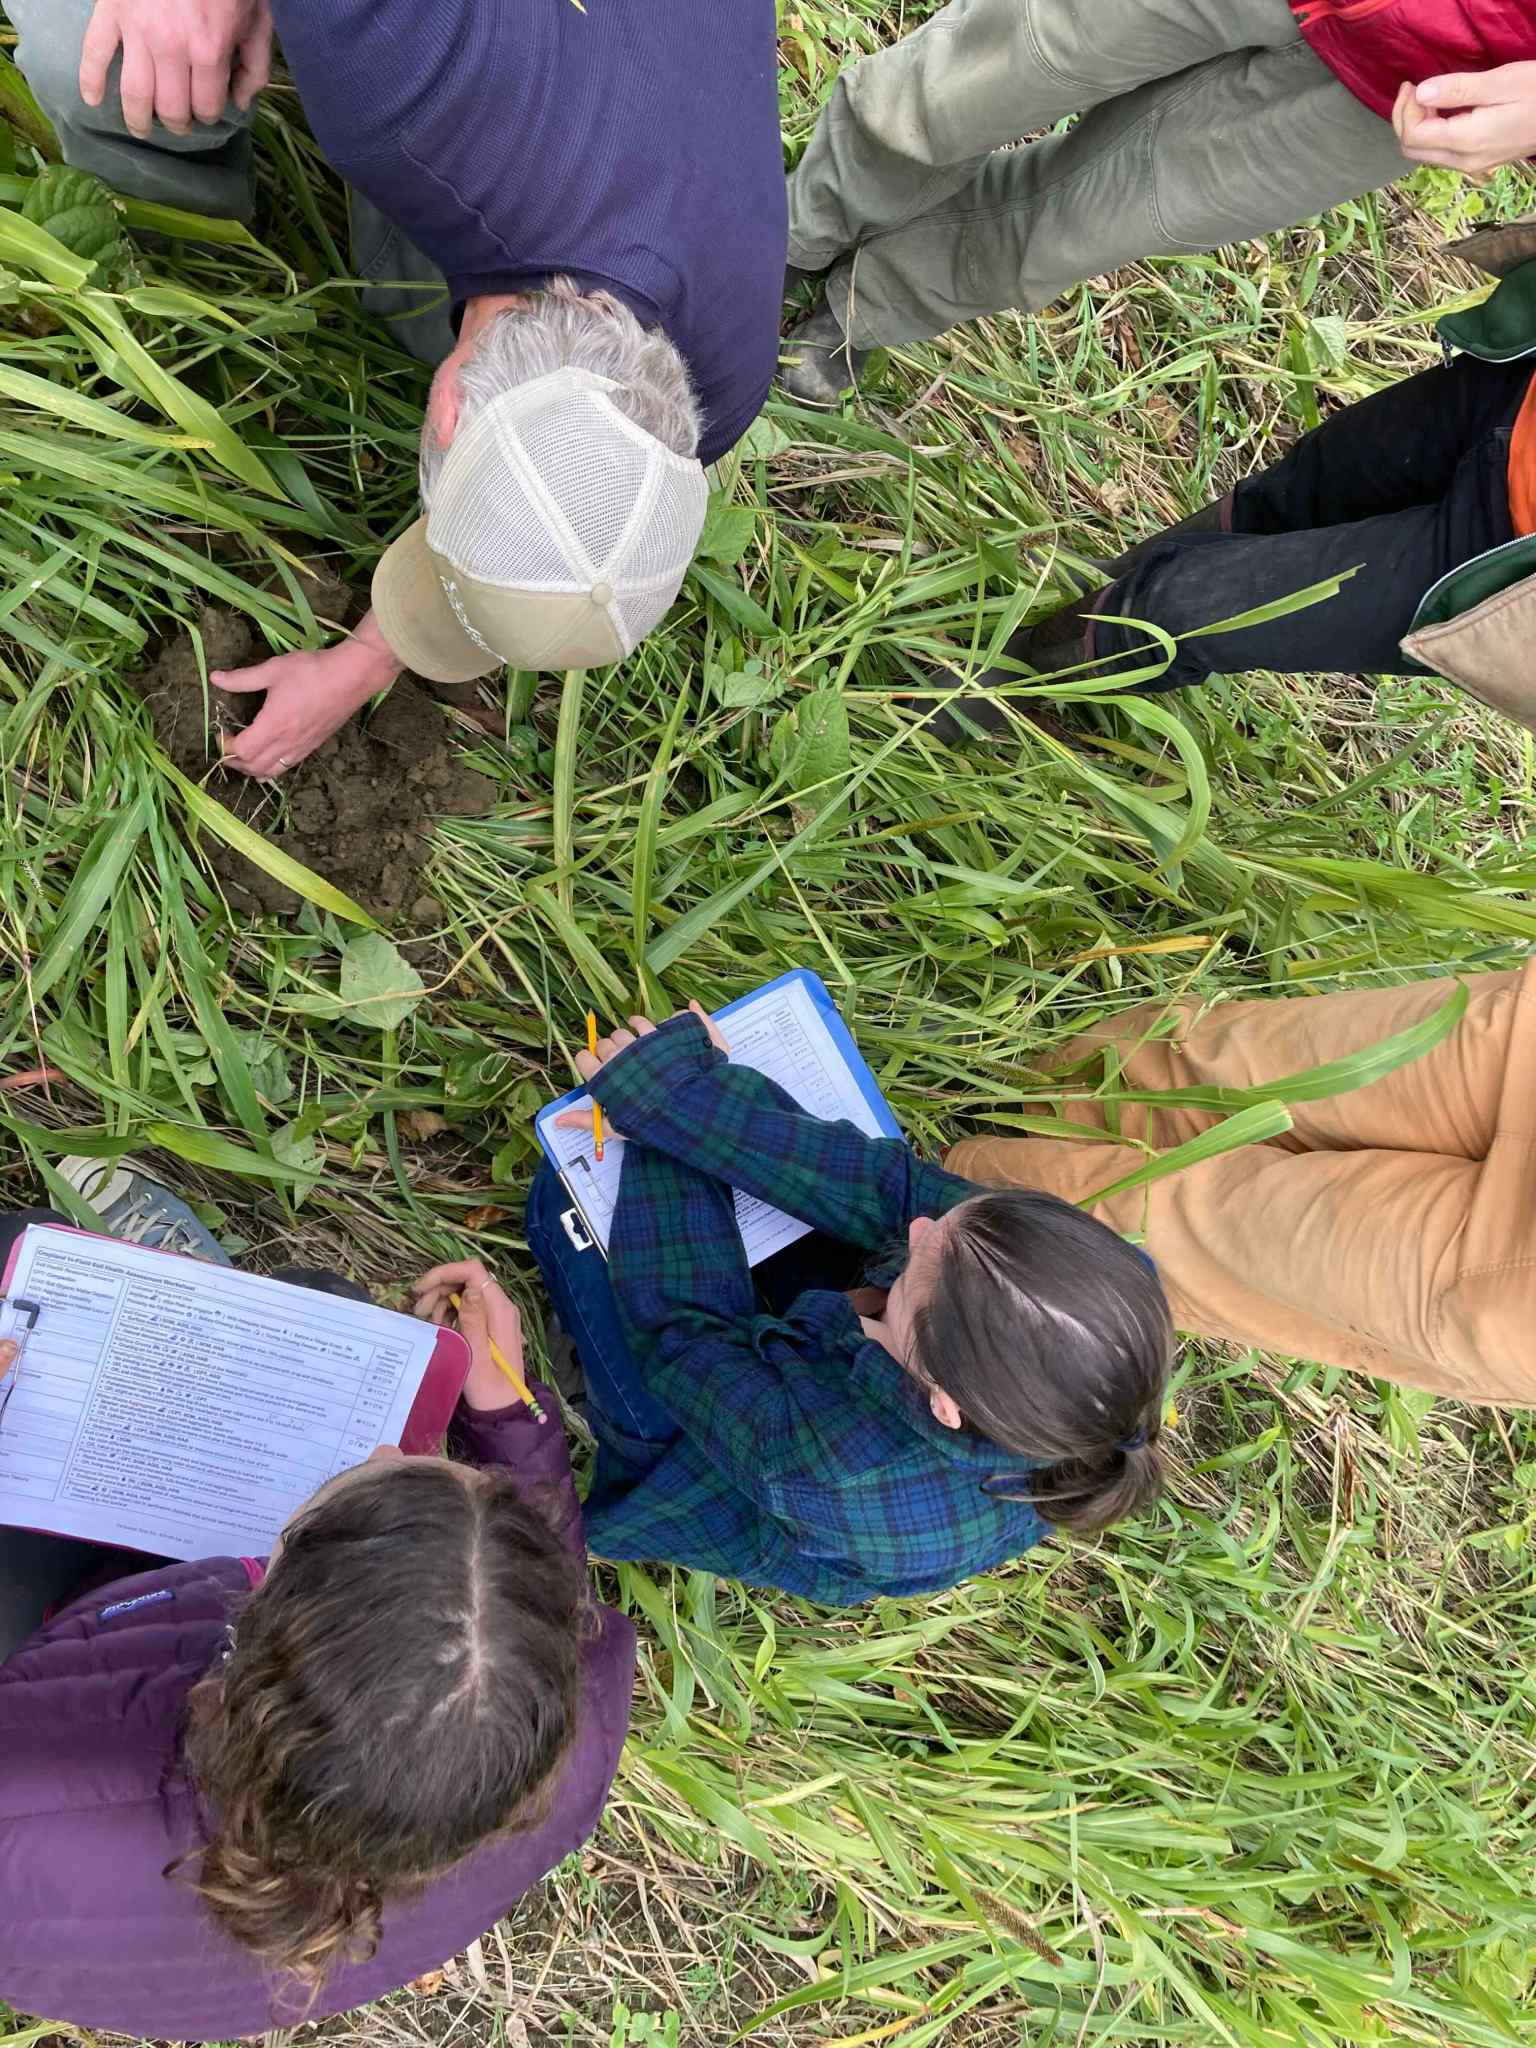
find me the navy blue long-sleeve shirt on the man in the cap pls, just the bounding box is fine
[272,0,788,463]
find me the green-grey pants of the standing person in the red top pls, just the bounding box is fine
[788,0,1407,348]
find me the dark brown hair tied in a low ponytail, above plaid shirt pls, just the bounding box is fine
[913,1188,1174,1534]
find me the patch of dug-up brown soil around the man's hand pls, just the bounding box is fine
[127,606,496,924]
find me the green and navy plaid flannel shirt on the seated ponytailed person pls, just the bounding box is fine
[588,1016,1049,1606]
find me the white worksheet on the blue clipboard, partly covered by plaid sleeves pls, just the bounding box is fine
[541,981,885,1266]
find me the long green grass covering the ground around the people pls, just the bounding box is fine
[0,0,1536,2048]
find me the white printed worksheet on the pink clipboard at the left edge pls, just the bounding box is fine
[0,1225,438,1559]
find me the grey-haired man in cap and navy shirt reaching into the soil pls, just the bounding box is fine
[6,0,786,776]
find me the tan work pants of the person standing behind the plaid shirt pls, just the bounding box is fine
[946,958,1536,1407]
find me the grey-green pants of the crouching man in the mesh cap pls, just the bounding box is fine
[4,0,455,365]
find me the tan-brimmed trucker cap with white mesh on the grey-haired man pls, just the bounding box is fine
[373,369,709,682]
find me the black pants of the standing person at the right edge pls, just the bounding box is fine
[1092,362,1530,690]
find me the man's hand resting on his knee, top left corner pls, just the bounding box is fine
[80,0,272,139]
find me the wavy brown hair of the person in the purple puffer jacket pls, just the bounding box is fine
[186,1458,586,1990]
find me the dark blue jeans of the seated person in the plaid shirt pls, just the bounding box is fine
[526,1161,680,1501]
